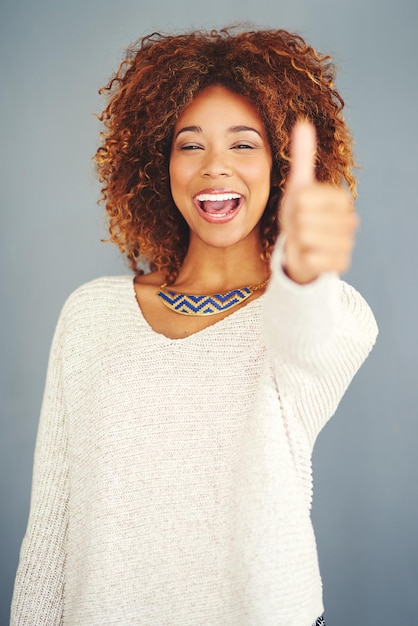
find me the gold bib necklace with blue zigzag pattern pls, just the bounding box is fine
[156,278,269,317]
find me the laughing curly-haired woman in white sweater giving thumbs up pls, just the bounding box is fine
[12,25,376,626]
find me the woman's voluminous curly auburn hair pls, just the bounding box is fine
[94,28,355,283]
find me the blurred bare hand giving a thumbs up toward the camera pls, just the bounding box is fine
[280,122,358,284]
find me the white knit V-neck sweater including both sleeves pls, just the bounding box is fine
[11,250,376,626]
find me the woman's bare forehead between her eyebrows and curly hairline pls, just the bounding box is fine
[176,85,264,129]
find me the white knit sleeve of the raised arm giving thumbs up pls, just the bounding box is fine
[262,236,378,446]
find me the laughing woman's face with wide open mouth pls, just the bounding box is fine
[170,86,272,248]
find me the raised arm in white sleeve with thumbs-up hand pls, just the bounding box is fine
[263,123,377,445]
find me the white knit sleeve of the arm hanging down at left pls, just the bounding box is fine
[10,304,69,626]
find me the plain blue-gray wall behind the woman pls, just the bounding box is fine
[0,0,418,626]
